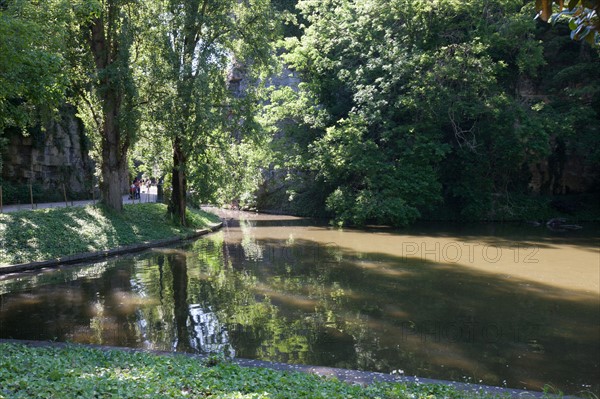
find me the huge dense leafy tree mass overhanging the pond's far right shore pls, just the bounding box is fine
[264,0,600,225]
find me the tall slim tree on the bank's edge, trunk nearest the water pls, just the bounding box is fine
[133,0,279,223]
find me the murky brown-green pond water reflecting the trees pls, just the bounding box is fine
[0,212,600,395]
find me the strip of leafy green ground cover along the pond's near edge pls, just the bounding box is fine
[0,344,524,399]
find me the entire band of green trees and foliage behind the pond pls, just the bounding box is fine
[0,0,600,226]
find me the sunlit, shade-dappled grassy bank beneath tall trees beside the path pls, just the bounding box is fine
[0,203,219,267]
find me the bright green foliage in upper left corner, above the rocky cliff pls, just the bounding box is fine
[0,0,68,171]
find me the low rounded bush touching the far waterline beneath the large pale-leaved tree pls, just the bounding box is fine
[310,120,440,225]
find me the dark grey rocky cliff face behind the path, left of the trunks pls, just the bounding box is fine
[2,107,94,196]
